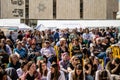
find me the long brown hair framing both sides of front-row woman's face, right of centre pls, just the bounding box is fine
[73,64,84,80]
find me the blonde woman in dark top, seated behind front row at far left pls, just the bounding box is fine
[8,54,21,70]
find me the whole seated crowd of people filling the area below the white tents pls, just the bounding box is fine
[0,27,120,80]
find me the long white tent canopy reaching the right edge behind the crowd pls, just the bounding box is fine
[37,20,120,29]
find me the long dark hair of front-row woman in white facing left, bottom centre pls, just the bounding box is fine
[51,63,60,80]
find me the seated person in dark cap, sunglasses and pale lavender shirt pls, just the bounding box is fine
[40,40,56,58]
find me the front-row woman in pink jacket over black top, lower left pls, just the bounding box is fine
[21,61,41,80]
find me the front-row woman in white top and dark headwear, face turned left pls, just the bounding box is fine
[47,63,65,80]
